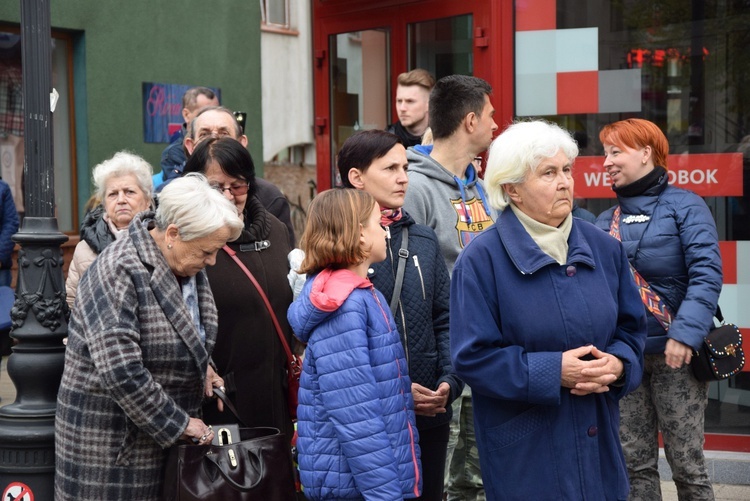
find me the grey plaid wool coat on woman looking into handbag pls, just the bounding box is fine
[55,213,217,501]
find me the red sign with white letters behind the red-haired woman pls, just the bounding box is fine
[573,153,743,198]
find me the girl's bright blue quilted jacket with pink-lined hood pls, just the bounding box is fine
[288,270,421,500]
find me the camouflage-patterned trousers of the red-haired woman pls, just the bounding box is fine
[620,353,714,501]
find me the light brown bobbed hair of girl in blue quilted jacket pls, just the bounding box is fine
[299,188,377,274]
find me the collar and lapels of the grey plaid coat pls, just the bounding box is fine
[129,212,217,371]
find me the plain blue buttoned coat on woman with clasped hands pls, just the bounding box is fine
[451,207,646,501]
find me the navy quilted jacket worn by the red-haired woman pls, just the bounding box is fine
[596,174,723,353]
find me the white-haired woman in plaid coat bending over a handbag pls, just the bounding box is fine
[55,174,243,501]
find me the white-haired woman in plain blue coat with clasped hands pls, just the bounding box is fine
[450,121,646,500]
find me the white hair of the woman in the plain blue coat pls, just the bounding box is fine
[484,120,578,211]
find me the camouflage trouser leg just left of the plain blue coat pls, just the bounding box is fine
[445,385,486,501]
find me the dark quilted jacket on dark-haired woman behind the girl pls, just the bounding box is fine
[368,212,464,429]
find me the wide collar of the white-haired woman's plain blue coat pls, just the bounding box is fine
[495,206,596,275]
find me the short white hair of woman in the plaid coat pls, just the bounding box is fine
[155,173,244,242]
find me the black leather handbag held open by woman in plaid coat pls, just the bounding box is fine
[164,392,297,501]
